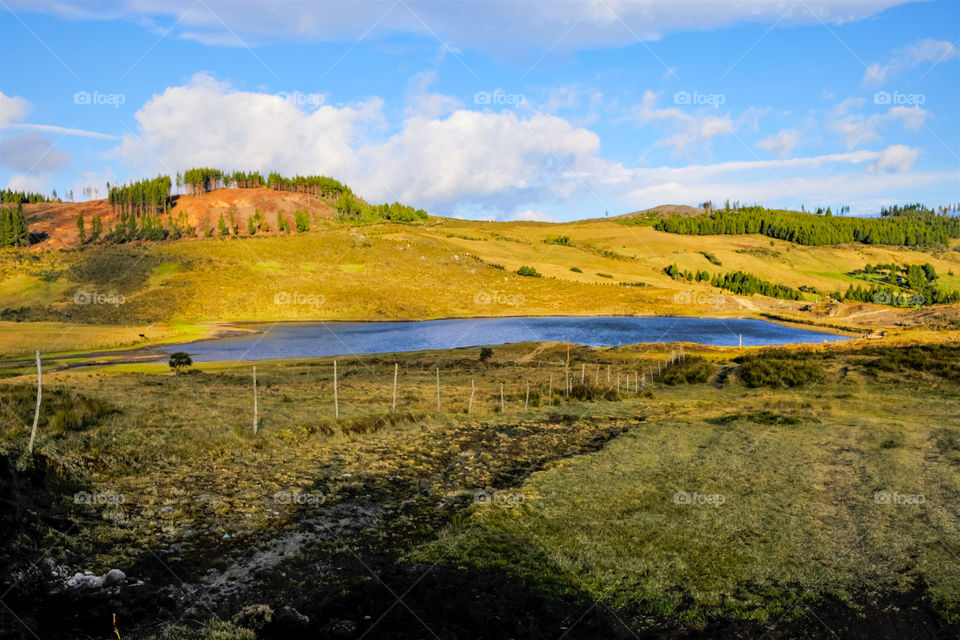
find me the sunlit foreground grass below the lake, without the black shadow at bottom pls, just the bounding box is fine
[0,344,960,637]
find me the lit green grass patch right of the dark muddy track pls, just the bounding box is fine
[416,383,960,623]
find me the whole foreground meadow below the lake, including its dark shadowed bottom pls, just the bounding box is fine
[0,341,960,639]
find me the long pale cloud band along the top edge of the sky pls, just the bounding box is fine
[8,0,908,61]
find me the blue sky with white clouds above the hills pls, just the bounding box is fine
[0,0,960,221]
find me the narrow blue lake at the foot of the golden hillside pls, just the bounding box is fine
[163,316,848,361]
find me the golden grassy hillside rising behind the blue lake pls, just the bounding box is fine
[0,189,960,355]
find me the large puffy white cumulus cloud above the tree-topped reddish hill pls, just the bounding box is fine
[112,74,600,205]
